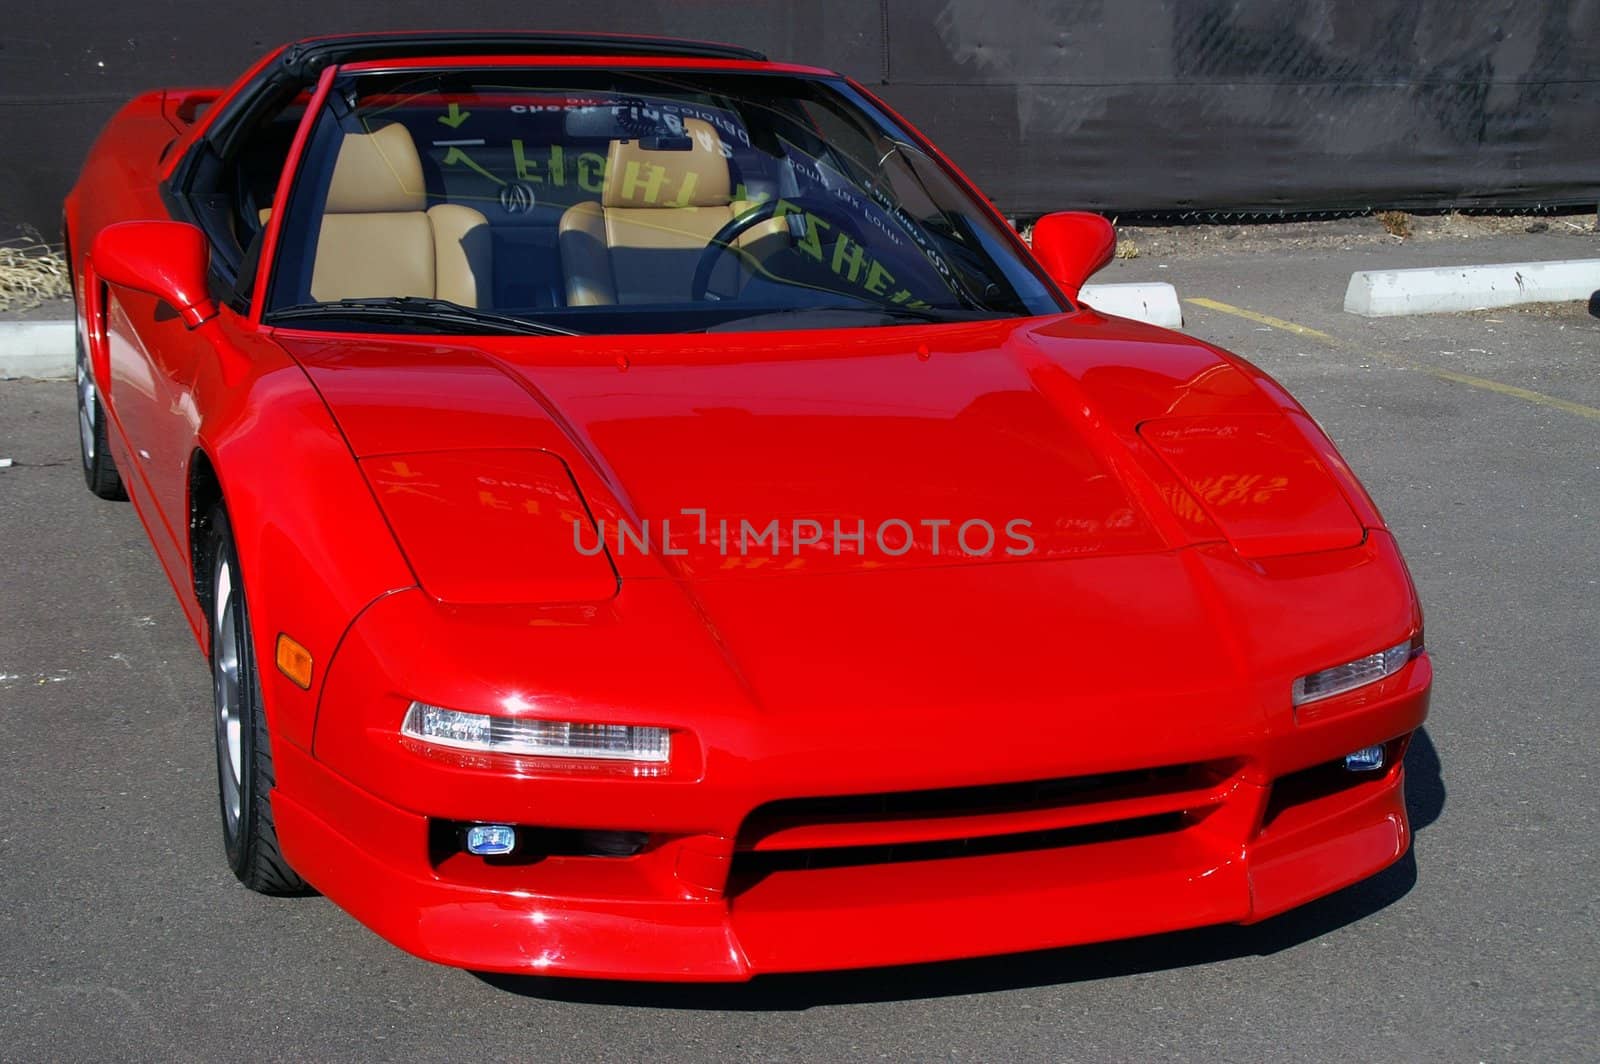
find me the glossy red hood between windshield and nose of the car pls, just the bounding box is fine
[275,312,1362,584]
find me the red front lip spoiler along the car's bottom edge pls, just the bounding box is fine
[277,742,1410,981]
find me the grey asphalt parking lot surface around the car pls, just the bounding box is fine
[0,237,1600,1061]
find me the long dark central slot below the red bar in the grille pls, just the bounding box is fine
[728,813,1195,894]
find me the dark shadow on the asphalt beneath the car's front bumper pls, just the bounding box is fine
[474,728,1445,1011]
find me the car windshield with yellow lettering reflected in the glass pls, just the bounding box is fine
[261,69,1062,333]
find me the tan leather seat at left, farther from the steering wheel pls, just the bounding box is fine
[310,123,493,307]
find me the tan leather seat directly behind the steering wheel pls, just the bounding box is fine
[560,118,787,307]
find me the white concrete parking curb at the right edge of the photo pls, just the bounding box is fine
[1344,259,1600,318]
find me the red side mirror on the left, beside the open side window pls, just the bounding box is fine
[90,222,216,328]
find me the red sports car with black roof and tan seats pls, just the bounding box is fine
[64,34,1430,979]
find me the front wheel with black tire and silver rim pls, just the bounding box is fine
[205,507,310,894]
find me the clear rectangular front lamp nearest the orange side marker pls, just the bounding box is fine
[400,702,672,763]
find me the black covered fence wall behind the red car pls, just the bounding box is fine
[0,0,1600,237]
